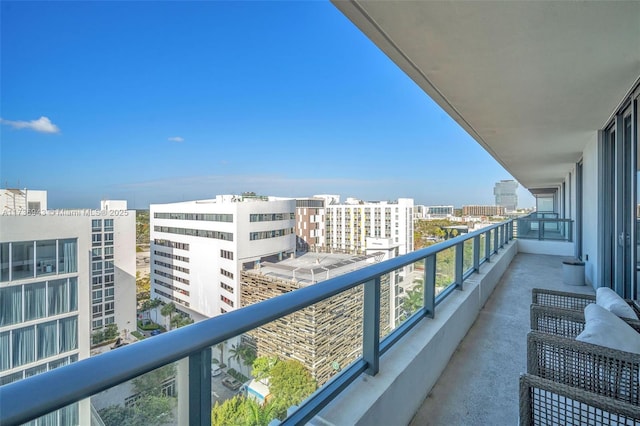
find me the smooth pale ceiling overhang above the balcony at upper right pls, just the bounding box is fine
[333,0,640,188]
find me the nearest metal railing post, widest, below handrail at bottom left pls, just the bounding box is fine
[189,348,211,426]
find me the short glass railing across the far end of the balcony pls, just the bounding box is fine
[516,213,573,242]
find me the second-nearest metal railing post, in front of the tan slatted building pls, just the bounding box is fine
[362,276,380,376]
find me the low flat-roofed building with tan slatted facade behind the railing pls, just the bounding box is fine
[241,251,394,385]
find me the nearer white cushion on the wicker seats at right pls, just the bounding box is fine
[576,303,640,354]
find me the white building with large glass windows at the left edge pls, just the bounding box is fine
[0,189,136,425]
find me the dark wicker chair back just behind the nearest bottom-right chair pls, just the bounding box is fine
[527,331,640,409]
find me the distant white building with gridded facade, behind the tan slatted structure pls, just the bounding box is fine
[325,198,413,255]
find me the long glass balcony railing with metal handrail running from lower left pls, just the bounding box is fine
[0,220,513,425]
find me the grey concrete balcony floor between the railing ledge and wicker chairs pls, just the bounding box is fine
[410,253,594,426]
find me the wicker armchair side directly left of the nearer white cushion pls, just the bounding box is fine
[530,304,640,339]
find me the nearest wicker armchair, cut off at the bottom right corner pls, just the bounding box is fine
[520,374,640,426]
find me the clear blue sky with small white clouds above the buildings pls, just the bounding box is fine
[0,1,534,208]
